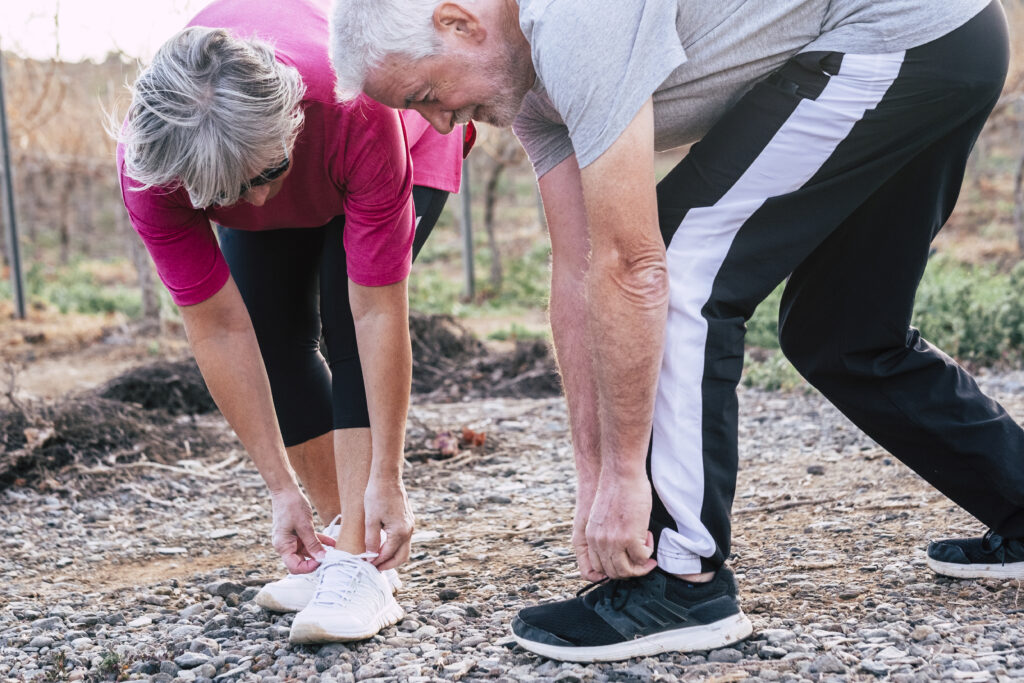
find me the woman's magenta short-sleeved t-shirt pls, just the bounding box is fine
[117,0,462,306]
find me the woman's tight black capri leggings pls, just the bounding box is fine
[217,186,449,446]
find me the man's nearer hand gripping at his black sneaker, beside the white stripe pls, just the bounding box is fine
[578,470,657,581]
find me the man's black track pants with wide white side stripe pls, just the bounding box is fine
[648,2,1024,573]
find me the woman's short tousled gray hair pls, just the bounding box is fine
[117,27,305,208]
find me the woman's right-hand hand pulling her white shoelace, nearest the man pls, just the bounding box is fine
[362,476,413,571]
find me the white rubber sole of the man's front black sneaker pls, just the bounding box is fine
[512,612,754,663]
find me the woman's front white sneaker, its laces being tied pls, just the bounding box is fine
[289,548,404,643]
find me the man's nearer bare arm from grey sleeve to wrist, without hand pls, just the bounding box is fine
[581,100,669,479]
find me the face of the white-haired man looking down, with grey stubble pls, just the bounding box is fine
[364,44,534,133]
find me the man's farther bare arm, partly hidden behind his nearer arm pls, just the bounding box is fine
[539,156,604,581]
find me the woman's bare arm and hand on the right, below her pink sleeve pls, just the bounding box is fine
[348,280,413,571]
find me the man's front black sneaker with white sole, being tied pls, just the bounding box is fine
[512,567,754,661]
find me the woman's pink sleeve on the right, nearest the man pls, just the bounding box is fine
[337,97,415,287]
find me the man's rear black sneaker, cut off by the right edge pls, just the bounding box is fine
[928,531,1024,579]
